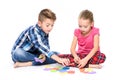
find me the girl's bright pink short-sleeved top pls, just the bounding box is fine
[74,27,100,54]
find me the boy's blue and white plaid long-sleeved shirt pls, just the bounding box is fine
[12,24,57,57]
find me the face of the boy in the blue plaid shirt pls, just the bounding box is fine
[38,19,54,34]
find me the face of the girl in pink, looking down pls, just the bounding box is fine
[78,18,93,35]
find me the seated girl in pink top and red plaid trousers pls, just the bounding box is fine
[71,10,106,68]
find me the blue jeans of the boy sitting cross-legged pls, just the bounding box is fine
[12,48,57,65]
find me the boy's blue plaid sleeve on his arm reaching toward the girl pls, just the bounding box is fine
[30,30,57,58]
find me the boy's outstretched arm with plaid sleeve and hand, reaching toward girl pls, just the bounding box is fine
[30,27,69,65]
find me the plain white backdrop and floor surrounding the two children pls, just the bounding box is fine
[0,0,120,80]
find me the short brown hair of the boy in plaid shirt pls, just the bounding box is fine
[38,9,56,22]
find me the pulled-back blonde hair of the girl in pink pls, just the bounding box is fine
[79,10,94,22]
